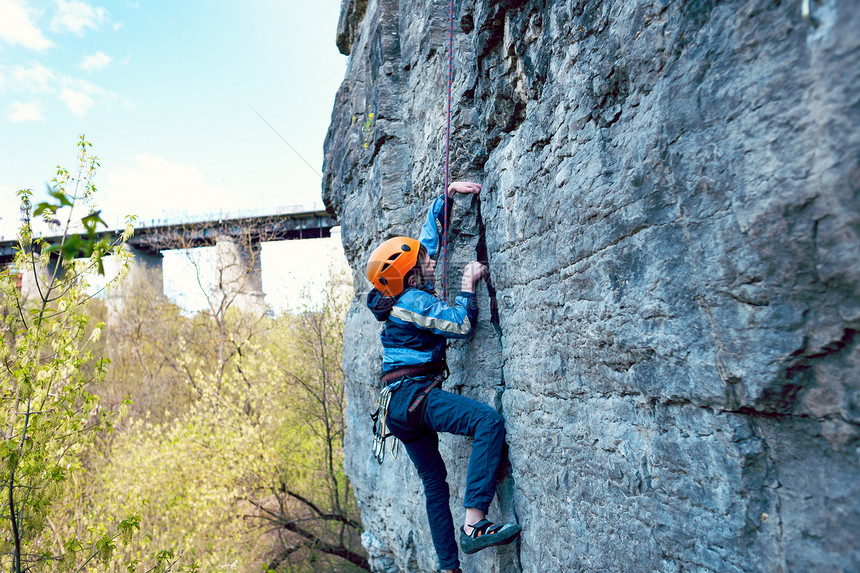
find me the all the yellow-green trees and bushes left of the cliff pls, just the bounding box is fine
[0,139,368,573]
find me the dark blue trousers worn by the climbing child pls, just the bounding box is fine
[387,377,505,569]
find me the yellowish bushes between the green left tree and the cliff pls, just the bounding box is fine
[70,254,367,571]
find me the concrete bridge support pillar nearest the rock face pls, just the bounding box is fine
[215,234,267,314]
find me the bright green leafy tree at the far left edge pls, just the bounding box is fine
[0,137,190,573]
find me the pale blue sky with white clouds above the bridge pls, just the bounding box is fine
[0,0,346,310]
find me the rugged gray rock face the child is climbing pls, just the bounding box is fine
[324,0,860,573]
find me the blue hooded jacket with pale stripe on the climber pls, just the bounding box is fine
[367,196,478,372]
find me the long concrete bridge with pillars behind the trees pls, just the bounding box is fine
[0,206,337,311]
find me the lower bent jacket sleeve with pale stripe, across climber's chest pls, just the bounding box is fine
[391,291,478,338]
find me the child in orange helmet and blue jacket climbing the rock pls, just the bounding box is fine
[367,181,520,572]
